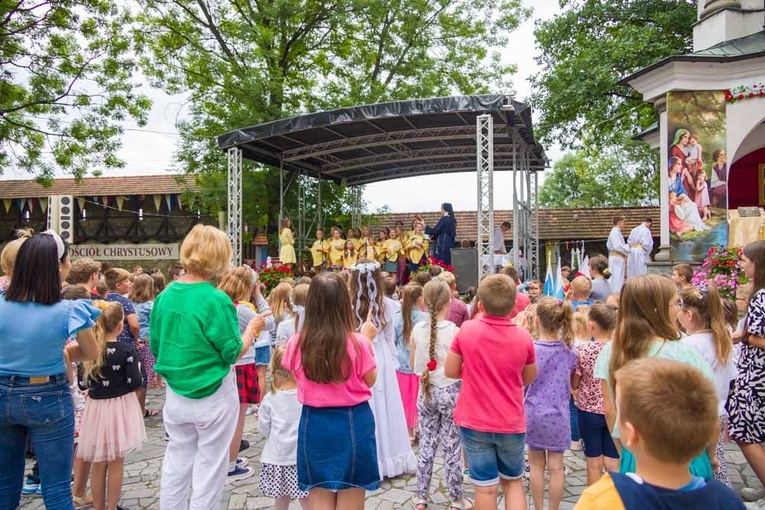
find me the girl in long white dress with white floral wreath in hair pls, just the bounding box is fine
[350,259,417,478]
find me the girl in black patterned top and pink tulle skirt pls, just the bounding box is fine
[76,300,151,510]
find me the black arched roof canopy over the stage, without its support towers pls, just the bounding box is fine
[218,95,547,186]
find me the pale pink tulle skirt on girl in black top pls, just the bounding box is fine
[77,392,146,462]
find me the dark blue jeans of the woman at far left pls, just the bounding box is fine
[0,374,74,510]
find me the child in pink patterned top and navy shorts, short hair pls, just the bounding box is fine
[571,303,619,485]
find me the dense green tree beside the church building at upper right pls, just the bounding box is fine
[532,0,697,207]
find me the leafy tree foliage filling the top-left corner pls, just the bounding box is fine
[0,0,151,182]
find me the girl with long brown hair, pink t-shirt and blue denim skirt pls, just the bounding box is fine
[282,273,380,510]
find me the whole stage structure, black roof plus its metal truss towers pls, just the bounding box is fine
[218,95,547,277]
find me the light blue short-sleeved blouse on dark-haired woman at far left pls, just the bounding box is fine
[0,297,101,377]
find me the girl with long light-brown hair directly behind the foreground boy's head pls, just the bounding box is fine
[594,275,718,478]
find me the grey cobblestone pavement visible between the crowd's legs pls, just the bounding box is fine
[19,390,760,510]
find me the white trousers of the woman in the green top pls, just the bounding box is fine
[159,371,239,510]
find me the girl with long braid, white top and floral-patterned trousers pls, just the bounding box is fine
[411,280,473,510]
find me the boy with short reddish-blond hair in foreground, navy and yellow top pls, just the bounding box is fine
[575,357,745,510]
